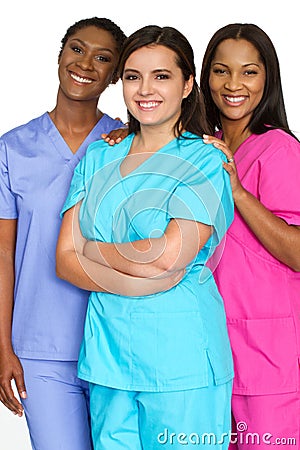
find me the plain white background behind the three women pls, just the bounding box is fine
[0,0,300,450]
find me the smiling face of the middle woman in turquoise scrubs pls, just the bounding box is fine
[122,44,193,134]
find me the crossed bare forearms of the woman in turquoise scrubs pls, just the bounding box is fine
[56,203,212,296]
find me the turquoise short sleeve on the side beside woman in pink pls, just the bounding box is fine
[168,149,233,246]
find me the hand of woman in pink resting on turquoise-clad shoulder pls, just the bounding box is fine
[203,134,244,199]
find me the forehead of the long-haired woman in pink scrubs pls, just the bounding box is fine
[213,39,261,65]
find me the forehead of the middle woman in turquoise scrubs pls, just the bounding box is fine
[125,44,179,71]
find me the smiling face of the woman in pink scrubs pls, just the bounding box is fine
[209,39,266,127]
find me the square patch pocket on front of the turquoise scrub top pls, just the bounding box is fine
[130,311,208,391]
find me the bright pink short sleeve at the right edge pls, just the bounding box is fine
[259,136,300,225]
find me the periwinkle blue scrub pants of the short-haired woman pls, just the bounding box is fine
[20,358,92,450]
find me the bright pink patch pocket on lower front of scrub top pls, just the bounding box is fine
[228,317,298,395]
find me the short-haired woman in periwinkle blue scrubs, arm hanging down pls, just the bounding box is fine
[0,17,125,450]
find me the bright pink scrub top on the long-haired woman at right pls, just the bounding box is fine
[212,130,300,395]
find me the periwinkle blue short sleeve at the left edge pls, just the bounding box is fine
[0,139,18,219]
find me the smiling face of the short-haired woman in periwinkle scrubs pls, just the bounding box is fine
[58,26,118,101]
